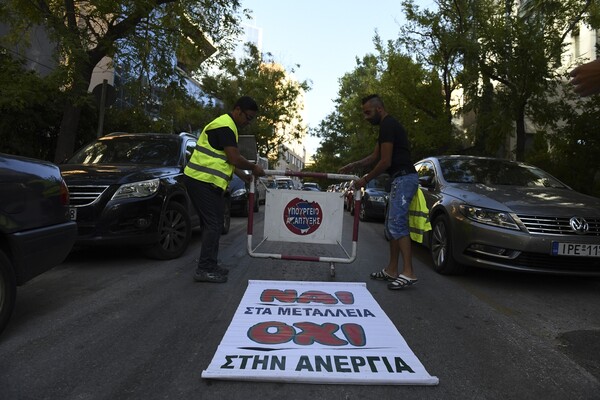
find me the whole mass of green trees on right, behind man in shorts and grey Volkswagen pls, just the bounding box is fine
[314,0,600,195]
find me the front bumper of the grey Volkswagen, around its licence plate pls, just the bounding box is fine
[452,219,600,276]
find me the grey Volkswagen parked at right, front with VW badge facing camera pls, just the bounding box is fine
[415,156,600,276]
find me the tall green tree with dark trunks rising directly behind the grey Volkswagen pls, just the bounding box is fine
[404,0,592,160]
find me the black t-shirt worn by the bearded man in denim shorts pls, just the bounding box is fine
[377,115,416,176]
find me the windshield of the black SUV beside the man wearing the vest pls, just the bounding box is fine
[68,136,179,166]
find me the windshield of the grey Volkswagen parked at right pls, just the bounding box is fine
[440,158,565,188]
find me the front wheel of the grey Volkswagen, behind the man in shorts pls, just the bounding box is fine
[430,215,465,275]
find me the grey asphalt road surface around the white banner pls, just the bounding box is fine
[0,211,600,400]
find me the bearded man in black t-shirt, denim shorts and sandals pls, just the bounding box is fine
[340,94,419,290]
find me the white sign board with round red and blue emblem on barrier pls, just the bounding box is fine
[264,189,344,244]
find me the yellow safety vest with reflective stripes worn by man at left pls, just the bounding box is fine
[183,114,238,190]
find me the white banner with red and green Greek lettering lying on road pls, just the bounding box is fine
[202,281,438,385]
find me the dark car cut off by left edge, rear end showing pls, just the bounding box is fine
[0,153,77,332]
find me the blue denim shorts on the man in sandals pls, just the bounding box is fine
[385,173,419,240]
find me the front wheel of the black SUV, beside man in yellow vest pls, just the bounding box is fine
[147,202,192,260]
